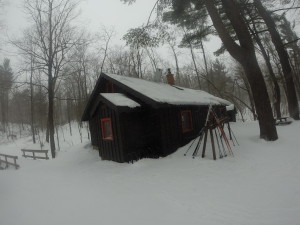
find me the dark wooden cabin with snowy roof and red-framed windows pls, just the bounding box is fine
[82,73,230,163]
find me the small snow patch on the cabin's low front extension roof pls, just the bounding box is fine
[100,93,141,108]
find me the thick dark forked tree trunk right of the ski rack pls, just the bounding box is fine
[204,0,278,141]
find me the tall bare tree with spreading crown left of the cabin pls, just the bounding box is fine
[13,0,80,158]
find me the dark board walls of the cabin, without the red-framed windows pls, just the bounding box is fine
[90,103,212,162]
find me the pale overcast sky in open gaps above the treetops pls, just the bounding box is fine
[0,0,299,71]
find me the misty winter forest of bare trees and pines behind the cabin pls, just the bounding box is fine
[0,0,300,154]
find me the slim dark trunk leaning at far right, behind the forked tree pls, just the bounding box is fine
[253,0,300,120]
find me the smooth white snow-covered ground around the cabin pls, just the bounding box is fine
[0,122,300,225]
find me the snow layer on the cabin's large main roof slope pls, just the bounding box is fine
[106,74,231,105]
